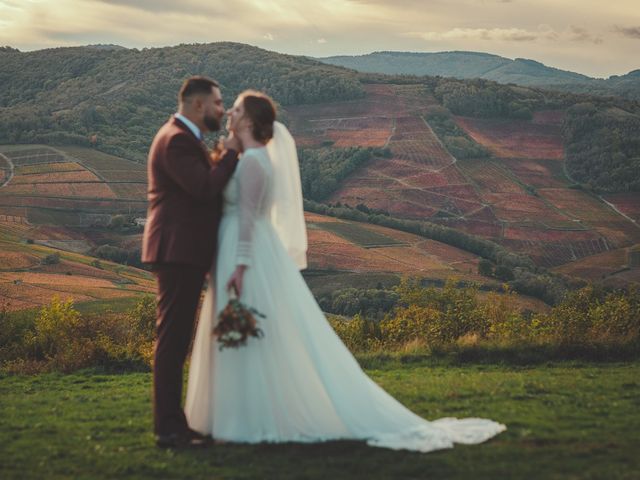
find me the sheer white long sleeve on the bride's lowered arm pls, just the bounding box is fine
[236,154,267,266]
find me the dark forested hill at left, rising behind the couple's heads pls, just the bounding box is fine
[0,42,362,161]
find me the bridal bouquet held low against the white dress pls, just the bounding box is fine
[213,298,266,350]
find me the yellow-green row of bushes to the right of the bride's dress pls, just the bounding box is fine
[332,278,640,358]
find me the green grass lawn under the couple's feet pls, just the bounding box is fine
[0,359,640,480]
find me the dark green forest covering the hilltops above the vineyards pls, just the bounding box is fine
[0,42,640,193]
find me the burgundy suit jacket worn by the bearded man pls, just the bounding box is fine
[142,117,238,269]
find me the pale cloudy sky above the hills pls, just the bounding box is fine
[0,0,640,78]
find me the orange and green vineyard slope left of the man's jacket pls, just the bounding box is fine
[0,145,146,225]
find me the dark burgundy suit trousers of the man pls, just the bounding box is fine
[153,264,206,435]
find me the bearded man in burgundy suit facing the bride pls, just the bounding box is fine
[142,77,240,447]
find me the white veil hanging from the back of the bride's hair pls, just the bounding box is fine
[267,122,307,270]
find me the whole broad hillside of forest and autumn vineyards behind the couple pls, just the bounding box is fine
[0,43,640,310]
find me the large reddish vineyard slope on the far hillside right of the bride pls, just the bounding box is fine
[287,84,640,278]
